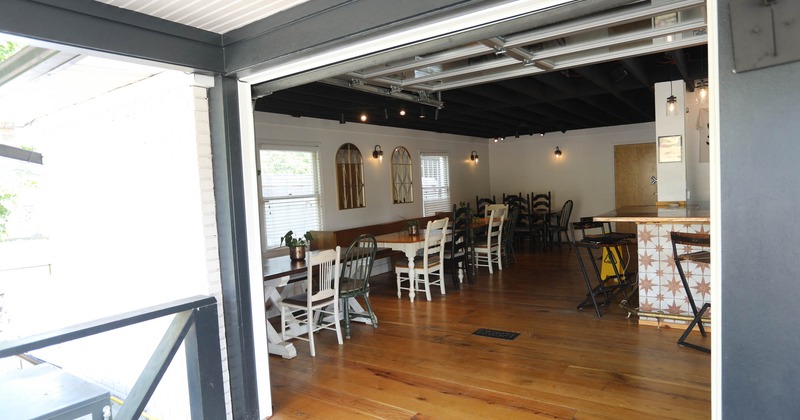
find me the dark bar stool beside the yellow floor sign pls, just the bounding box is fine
[570,218,638,317]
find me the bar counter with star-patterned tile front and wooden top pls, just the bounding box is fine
[593,205,711,324]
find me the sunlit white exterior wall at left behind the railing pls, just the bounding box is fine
[14,70,225,418]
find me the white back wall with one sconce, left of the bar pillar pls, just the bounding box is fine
[489,123,655,221]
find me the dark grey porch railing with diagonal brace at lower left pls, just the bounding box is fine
[0,296,225,420]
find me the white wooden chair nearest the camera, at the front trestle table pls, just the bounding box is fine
[280,246,342,356]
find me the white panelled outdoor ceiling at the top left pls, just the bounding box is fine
[96,0,308,34]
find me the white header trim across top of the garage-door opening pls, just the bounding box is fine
[250,0,639,97]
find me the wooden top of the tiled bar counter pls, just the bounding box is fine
[593,205,711,223]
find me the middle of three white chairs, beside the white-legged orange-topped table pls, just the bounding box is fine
[394,217,449,302]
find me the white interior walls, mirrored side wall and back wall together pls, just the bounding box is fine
[255,111,709,233]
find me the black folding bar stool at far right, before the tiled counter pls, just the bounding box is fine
[669,232,711,353]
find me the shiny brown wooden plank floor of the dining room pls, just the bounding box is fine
[269,246,711,419]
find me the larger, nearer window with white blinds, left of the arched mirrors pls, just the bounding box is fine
[259,147,322,248]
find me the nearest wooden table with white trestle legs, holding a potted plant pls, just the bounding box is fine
[263,248,393,359]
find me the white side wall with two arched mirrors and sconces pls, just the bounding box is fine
[254,112,491,230]
